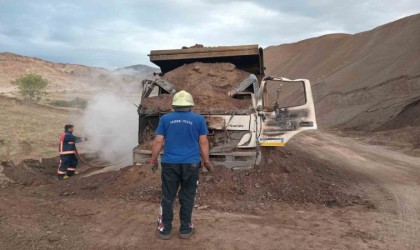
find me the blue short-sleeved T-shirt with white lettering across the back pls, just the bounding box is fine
[156,112,208,164]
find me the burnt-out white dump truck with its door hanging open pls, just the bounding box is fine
[133,45,317,170]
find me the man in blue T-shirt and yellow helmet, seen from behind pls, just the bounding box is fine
[150,90,214,240]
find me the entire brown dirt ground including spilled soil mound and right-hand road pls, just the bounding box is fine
[0,131,420,249]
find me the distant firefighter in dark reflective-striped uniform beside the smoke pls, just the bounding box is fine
[57,124,87,180]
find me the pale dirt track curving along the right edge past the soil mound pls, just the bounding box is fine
[293,131,420,249]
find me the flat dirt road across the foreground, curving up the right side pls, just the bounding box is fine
[0,131,420,249]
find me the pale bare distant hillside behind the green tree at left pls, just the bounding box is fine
[0,52,157,93]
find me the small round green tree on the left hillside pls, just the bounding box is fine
[11,74,49,103]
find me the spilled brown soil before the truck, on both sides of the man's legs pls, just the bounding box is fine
[50,148,365,213]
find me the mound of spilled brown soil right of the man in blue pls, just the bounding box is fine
[198,147,365,212]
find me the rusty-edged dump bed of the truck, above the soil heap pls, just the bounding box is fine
[149,45,264,78]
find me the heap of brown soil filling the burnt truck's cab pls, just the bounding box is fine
[143,62,252,111]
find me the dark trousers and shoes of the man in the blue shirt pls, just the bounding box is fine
[158,162,200,234]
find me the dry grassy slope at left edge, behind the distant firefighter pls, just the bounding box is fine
[0,96,71,162]
